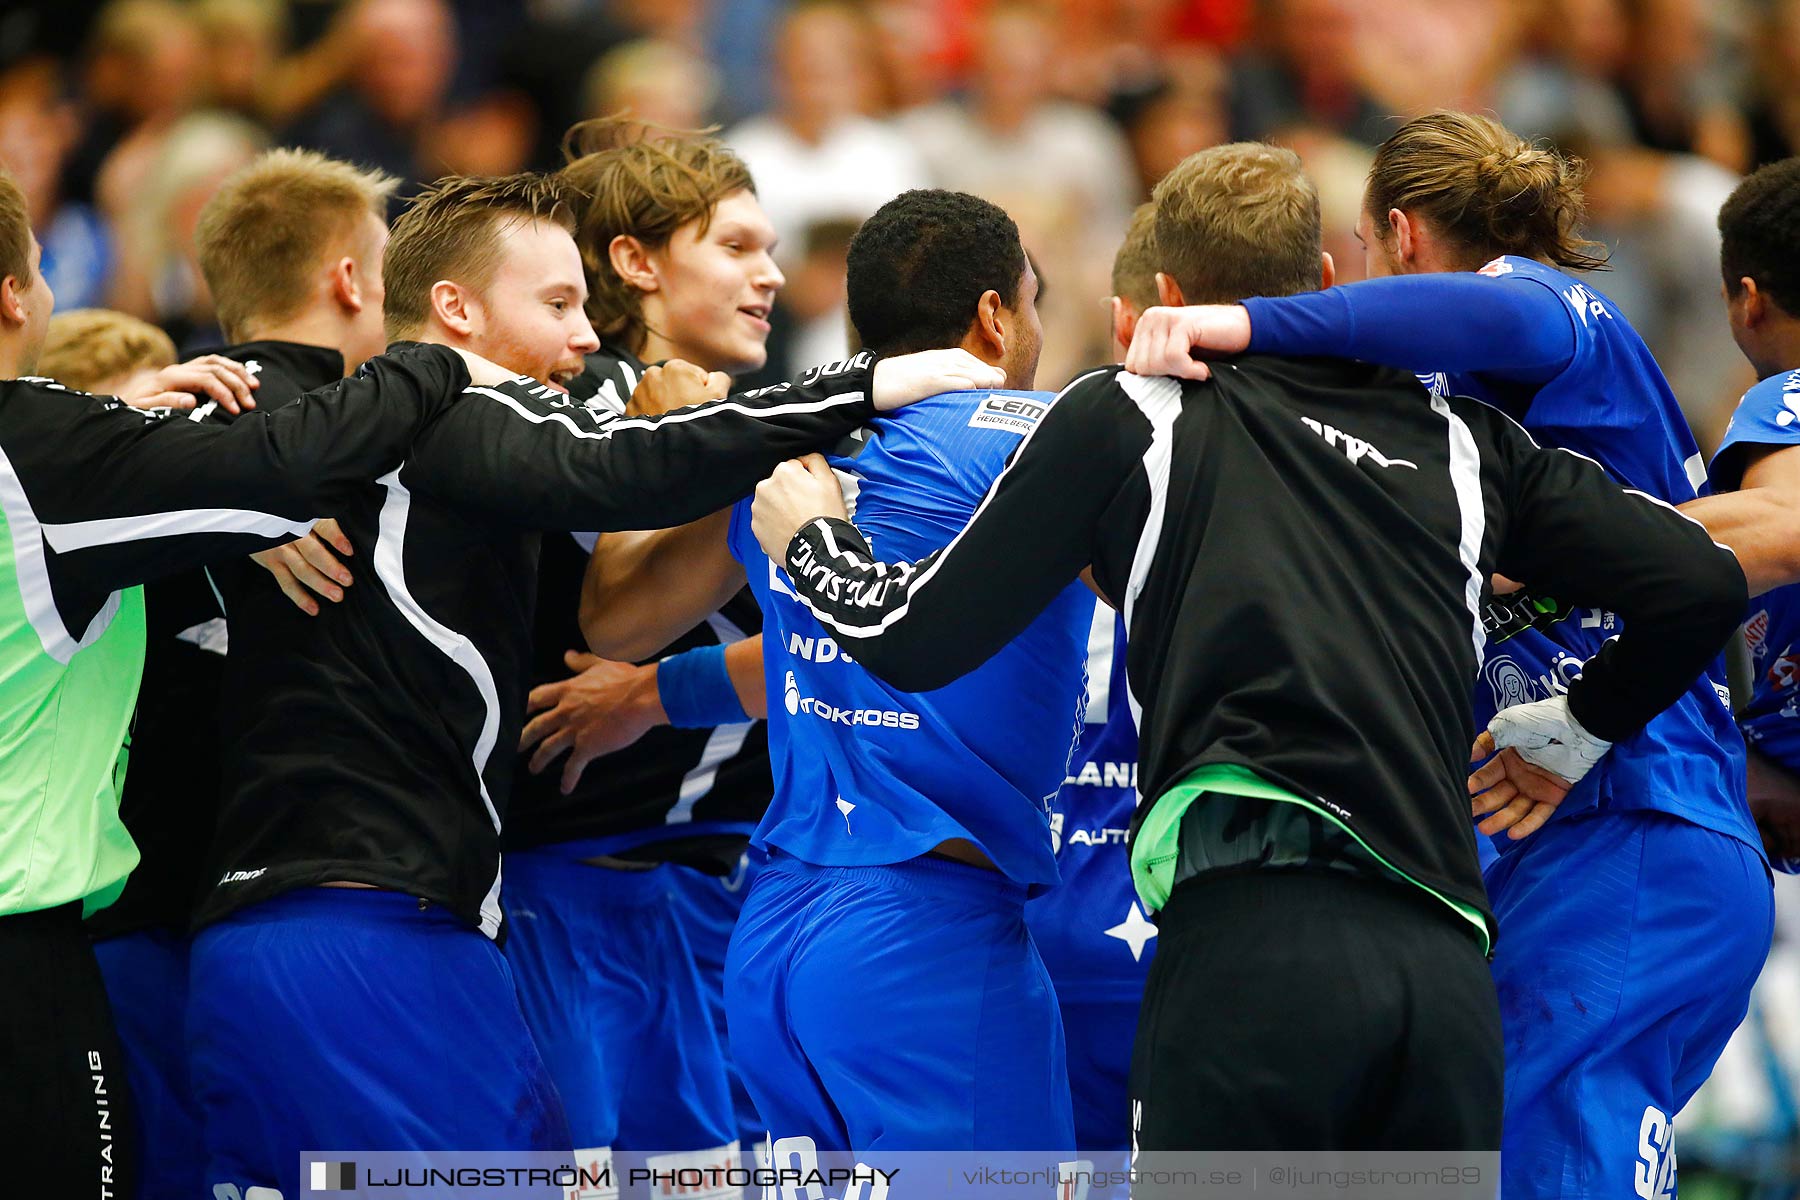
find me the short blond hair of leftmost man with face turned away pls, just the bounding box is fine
[194,149,396,340]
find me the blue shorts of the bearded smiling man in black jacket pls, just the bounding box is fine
[187,887,572,1196]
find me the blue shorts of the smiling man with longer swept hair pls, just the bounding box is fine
[500,851,738,1153]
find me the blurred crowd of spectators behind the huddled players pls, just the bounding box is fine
[0,0,1800,1184]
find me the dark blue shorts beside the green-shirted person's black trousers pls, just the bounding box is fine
[94,928,207,1200]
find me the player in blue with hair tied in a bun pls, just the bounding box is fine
[1129,112,1773,1196]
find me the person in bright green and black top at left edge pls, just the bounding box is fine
[0,161,482,1196]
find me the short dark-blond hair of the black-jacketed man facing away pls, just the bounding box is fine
[1150,142,1325,304]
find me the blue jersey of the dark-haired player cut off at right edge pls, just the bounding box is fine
[1712,371,1800,873]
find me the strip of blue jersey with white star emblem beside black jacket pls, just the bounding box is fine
[1024,603,1156,1000]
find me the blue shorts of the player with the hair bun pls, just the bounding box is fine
[1487,810,1775,1200]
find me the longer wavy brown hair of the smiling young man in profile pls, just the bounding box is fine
[560,117,756,351]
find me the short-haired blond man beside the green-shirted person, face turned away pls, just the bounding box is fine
[70,149,394,1196]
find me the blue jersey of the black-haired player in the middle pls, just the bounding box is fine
[731,392,1093,885]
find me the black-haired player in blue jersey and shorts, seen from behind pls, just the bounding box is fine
[583,191,1094,1153]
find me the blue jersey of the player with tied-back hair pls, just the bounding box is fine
[1426,255,1762,853]
